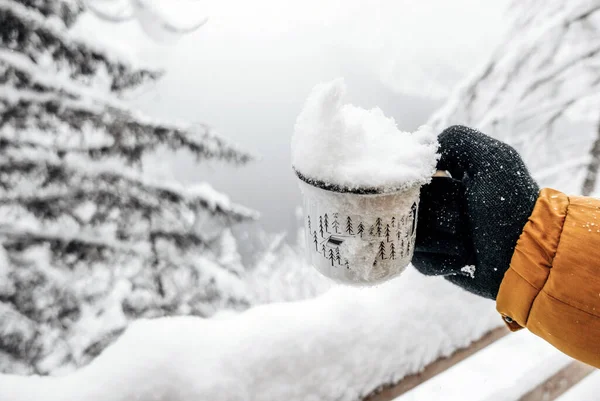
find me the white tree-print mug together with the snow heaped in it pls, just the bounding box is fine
[292,78,438,285]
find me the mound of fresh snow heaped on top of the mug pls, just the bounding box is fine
[292,78,437,192]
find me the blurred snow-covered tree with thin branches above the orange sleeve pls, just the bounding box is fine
[430,0,600,194]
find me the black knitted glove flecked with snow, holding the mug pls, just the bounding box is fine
[413,126,539,299]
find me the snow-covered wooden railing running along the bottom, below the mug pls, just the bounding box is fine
[0,269,597,401]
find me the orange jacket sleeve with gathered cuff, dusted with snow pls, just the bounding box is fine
[496,189,600,368]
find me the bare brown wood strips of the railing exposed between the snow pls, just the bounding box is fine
[364,327,595,401]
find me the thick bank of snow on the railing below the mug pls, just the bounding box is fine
[0,269,500,401]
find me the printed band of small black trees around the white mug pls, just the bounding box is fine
[306,203,418,269]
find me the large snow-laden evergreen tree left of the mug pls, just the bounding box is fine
[0,0,255,373]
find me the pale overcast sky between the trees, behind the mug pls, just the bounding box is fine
[81,0,506,230]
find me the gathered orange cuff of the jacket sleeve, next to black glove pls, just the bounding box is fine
[496,188,569,331]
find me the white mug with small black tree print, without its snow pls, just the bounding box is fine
[300,179,420,285]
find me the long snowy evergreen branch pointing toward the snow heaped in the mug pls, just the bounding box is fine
[0,87,253,164]
